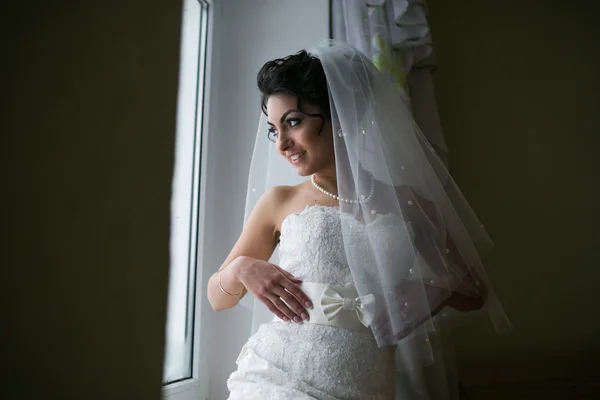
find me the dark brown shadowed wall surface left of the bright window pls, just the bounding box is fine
[0,0,181,400]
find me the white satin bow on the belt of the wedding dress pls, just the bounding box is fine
[321,286,375,328]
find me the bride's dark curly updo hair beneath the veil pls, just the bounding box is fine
[257,50,331,119]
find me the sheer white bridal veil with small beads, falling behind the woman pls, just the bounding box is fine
[242,40,511,399]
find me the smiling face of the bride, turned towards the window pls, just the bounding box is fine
[266,94,335,176]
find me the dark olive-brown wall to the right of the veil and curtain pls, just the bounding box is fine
[429,0,600,383]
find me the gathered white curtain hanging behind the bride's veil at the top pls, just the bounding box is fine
[331,0,448,164]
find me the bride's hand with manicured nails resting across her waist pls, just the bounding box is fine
[235,257,312,323]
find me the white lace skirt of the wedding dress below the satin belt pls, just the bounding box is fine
[227,322,394,400]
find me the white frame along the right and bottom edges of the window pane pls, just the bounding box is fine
[162,0,214,400]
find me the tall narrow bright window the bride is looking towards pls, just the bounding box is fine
[163,0,212,399]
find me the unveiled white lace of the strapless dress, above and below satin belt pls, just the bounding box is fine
[227,206,394,400]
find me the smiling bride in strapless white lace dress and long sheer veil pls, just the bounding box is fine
[208,41,509,400]
